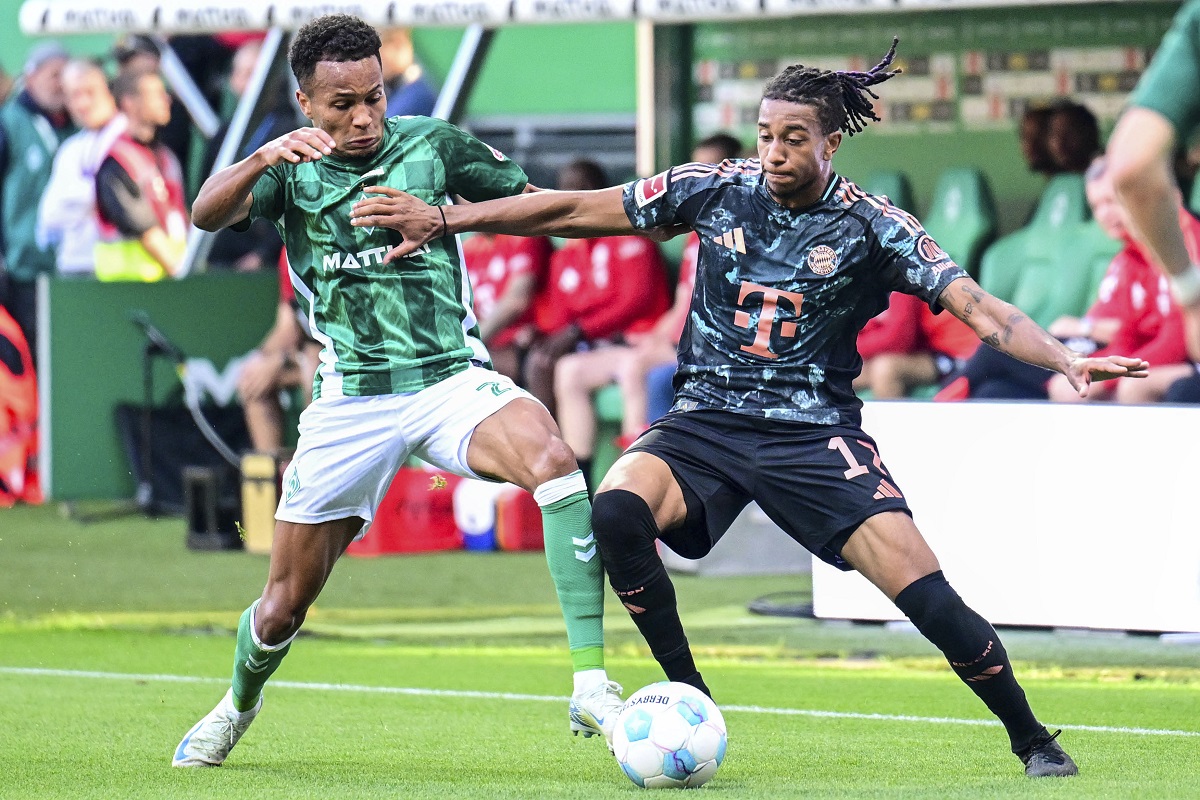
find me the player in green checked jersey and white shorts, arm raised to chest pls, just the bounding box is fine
[173,14,620,766]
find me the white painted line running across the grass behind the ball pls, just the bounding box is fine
[0,667,1200,736]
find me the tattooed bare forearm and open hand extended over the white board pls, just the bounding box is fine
[937,278,1150,397]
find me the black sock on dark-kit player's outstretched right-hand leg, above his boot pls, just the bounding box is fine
[895,570,1044,753]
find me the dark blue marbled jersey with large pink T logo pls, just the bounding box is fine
[624,158,966,425]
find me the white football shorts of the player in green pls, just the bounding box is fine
[275,365,533,539]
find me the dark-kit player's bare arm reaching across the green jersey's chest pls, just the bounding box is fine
[350,186,641,261]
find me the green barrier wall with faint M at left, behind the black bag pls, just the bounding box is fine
[42,272,278,500]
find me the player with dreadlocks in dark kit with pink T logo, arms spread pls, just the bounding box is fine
[353,38,1147,776]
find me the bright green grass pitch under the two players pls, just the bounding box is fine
[0,510,1200,800]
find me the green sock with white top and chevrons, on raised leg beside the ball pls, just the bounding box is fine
[534,470,604,672]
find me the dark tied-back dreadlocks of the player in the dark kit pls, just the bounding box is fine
[762,38,900,136]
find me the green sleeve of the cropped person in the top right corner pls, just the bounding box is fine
[1129,0,1200,139]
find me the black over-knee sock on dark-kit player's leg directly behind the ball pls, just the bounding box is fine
[592,489,713,697]
